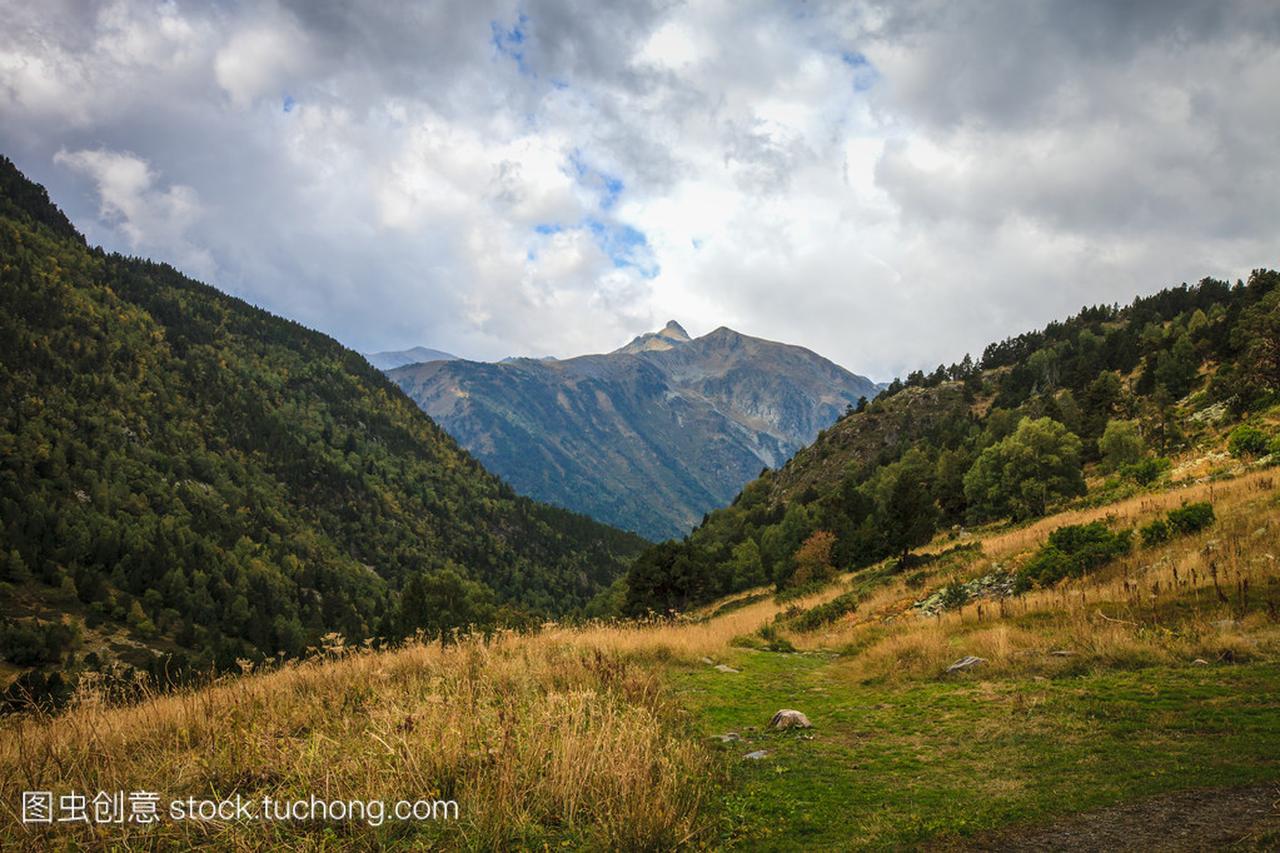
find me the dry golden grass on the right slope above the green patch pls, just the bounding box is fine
[787,474,1280,679]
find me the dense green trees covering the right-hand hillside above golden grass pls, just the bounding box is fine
[626,270,1280,612]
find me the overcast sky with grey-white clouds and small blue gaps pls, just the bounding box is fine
[0,0,1280,379]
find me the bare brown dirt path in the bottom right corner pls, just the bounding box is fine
[938,783,1280,852]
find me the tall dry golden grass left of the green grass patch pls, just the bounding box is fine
[0,631,717,849]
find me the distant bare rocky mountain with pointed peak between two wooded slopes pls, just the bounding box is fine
[388,321,877,539]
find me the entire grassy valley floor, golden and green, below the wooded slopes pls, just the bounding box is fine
[0,435,1280,850]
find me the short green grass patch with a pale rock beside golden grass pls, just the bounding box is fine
[675,652,1280,849]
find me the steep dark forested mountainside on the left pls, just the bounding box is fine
[0,160,645,696]
